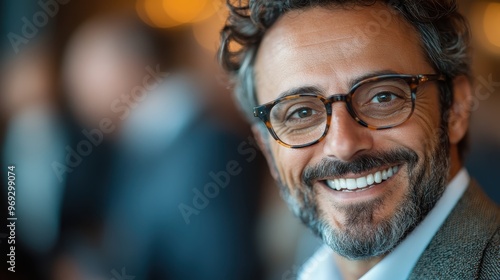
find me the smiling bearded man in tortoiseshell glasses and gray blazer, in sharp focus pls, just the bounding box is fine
[220,0,500,279]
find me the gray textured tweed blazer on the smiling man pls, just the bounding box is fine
[410,181,500,280]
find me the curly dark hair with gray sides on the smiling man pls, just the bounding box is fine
[219,0,471,156]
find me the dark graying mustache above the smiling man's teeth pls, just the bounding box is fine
[302,148,419,187]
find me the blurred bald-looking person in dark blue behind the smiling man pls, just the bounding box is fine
[54,12,266,279]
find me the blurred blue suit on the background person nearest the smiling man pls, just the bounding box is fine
[100,77,268,280]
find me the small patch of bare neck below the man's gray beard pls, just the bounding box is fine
[334,254,384,280]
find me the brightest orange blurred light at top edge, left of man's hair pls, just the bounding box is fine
[163,0,209,23]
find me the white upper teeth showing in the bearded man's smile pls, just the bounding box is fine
[323,166,400,192]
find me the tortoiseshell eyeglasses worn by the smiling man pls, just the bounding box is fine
[254,74,446,148]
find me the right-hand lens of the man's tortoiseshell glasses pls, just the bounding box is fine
[351,78,413,127]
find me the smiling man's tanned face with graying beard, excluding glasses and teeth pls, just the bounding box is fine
[255,5,449,259]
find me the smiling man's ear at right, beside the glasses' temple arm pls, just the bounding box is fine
[448,76,472,144]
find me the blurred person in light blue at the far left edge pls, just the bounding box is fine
[0,37,67,279]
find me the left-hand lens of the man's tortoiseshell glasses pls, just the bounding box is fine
[270,96,327,145]
